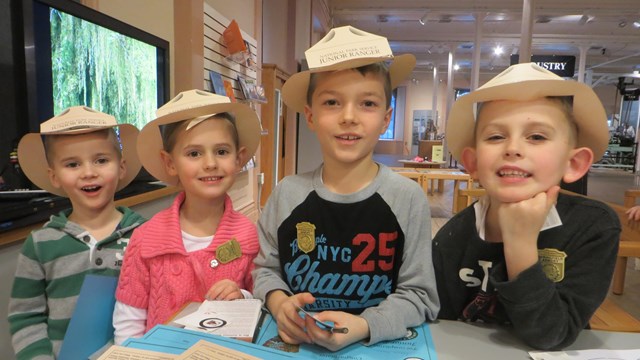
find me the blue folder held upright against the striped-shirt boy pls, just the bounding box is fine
[58,275,118,360]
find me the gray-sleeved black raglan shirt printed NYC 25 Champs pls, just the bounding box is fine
[253,164,439,344]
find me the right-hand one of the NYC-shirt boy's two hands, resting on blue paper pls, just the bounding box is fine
[305,311,369,351]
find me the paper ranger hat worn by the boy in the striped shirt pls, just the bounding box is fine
[18,106,141,197]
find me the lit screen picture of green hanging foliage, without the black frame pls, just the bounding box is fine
[49,8,161,128]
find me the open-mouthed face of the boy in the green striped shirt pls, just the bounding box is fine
[49,131,126,212]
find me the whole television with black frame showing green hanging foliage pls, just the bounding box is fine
[24,0,169,132]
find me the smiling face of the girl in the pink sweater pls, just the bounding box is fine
[162,118,244,200]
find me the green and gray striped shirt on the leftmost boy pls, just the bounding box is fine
[9,207,145,359]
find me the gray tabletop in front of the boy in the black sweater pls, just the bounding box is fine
[429,320,640,360]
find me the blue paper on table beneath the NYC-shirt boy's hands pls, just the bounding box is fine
[256,315,437,360]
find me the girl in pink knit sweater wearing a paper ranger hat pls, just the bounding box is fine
[113,90,261,344]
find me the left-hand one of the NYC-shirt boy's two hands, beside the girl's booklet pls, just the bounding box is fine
[267,290,315,344]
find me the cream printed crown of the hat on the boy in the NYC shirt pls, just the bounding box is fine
[304,26,393,70]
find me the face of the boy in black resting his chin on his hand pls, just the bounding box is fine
[463,98,575,202]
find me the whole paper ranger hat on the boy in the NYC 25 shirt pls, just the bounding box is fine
[282,26,416,113]
